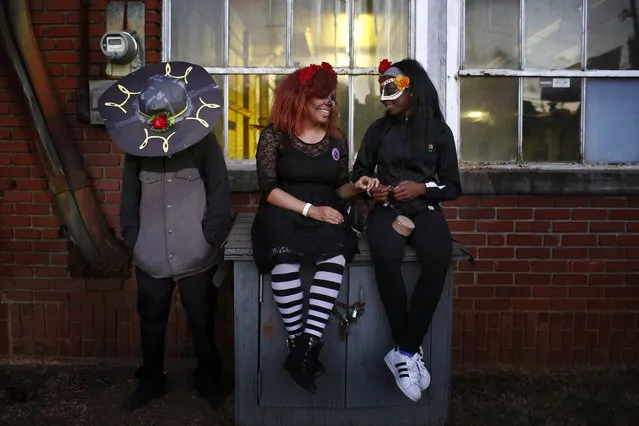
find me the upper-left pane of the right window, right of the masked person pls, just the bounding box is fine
[464,0,519,69]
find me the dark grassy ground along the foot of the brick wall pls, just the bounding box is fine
[0,364,639,426]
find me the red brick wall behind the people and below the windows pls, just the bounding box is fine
[0,0,639,367]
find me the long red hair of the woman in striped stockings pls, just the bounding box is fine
[271,67,342,139]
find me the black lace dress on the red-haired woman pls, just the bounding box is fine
[252,125,357,273]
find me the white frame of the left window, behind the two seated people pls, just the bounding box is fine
[162,0,429,170]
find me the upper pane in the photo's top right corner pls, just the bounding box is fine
[588,0,639,70]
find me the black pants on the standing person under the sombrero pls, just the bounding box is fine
[135,268,222,384]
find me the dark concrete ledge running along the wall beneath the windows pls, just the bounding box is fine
[229,166,639,196]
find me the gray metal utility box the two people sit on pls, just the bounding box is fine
[225,213,468,426]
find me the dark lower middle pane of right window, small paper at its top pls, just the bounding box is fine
[523,78,581,162]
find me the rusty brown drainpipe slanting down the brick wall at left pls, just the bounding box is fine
[0,0,130,278]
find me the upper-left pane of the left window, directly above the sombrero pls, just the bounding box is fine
[171,0,224,66]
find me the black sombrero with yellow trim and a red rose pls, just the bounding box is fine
[98,62,223,157]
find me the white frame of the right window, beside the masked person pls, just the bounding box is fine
[448,0,639,170]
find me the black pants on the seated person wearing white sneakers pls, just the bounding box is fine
[367,206,453,353]
